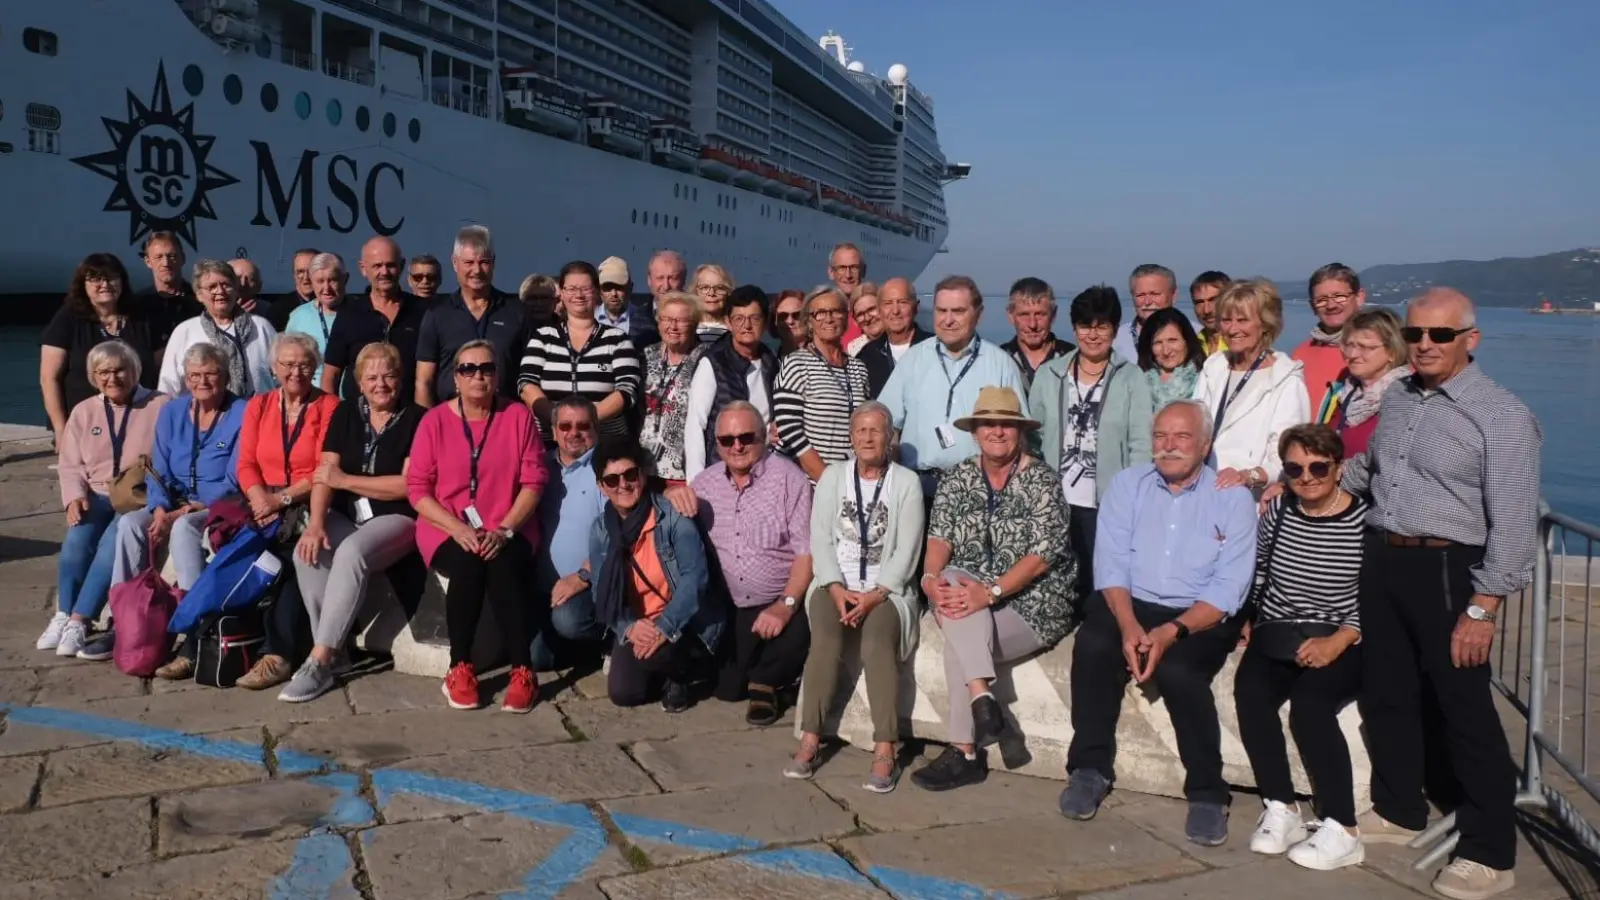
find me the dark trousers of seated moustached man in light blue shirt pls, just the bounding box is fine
[1067,594,1238,804]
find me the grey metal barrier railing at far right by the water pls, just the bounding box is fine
[1410,503,1600,871]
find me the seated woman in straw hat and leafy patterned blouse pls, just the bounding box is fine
[912,386,1078,791]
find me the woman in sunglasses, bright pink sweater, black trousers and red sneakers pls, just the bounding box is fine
[405,341,550,713]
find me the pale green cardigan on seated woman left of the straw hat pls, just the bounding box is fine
[806,458,926,661]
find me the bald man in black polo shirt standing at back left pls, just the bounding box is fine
[322,237,427,400]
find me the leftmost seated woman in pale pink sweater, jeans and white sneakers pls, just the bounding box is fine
[35,341,168,660]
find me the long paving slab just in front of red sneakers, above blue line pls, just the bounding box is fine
[282,701,571,767]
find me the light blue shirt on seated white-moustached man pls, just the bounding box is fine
[1094,463,1256,615]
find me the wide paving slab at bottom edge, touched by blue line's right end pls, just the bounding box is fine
[842,810,1203,898]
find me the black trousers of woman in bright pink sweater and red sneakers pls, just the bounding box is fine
[434,535,533,666]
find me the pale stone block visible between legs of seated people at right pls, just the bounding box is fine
[797,613,1371,797]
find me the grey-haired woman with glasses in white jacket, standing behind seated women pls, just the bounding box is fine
[158,259,278,390]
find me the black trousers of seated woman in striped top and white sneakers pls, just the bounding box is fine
[1234,645,1362,828]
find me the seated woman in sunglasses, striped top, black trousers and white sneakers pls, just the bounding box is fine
[1230,422,1366,870]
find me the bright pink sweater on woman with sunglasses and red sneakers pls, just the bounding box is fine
[405,399,550,565]
